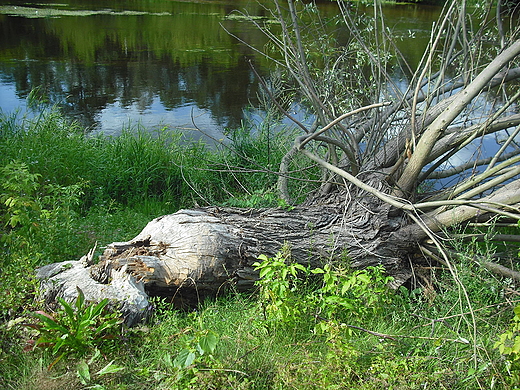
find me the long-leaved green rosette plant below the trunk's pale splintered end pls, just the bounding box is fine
[30,288,121,367]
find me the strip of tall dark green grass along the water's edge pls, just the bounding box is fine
[0,105,296,210]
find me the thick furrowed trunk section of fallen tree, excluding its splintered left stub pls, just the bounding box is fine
[93,202,412,290]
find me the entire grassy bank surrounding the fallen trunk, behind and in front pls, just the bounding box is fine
[0,105,520,390]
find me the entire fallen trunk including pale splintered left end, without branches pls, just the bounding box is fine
[38,193,415,324]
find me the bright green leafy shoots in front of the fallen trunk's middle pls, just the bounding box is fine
[253,248,391,329]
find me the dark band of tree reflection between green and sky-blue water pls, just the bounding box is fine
[2,50,257,127]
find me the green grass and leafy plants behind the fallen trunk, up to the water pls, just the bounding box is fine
[0,106,296,318]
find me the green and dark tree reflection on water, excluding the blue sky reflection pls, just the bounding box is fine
[0,3,268,126]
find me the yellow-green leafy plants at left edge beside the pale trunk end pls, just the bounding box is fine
[0,161,82,315]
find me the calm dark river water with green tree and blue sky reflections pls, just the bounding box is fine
[0,0,440,138]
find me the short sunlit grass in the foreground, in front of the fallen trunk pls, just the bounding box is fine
[7,276,513,389]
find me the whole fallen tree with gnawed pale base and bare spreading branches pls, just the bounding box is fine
[39,0,520,323]
